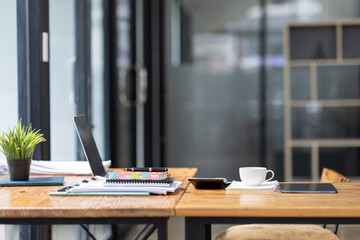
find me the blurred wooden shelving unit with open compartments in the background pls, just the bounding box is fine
[283,19,360,181]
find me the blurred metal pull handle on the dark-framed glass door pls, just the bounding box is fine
[119,64,148,108]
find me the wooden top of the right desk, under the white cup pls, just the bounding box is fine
[175,183,360,218]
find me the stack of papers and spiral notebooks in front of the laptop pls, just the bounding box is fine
[50,170,182,196]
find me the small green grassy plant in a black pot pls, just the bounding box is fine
[0,119,46,181]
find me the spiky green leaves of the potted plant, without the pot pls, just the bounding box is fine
[0,119,46,159]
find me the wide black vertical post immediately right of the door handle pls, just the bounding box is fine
[144,1,165,166]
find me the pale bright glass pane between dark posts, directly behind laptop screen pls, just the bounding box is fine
[49,0,77,161]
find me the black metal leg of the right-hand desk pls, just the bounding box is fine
[185,217,211,240]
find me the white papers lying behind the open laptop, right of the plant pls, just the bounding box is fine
[30,160,111,175]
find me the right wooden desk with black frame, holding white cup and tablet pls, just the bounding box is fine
[175,183,360,239]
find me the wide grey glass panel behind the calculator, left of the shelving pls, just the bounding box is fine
[167,0,260,179]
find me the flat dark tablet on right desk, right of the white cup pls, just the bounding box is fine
[280,183,337,193]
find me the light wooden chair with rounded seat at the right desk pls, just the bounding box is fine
[215,168,350,240]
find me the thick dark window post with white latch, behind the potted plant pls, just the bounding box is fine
[17,0,51,240]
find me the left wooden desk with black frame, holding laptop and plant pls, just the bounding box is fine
[0,168,197,239]
